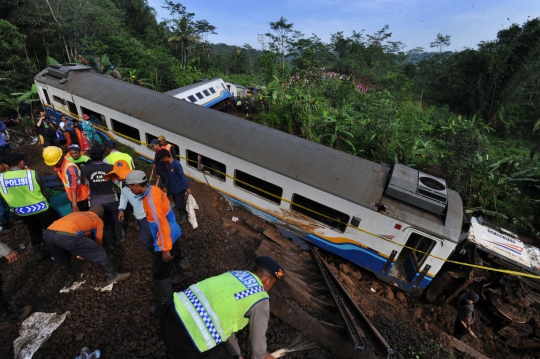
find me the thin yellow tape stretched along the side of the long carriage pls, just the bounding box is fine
[45,104,540,279]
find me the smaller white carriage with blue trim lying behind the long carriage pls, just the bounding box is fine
[165,78,233,107]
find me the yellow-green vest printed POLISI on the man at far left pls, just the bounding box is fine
[0,170,49,216]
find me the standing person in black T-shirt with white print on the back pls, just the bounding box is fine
[81,146,125,252]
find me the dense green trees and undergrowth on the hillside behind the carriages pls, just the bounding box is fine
[0,0,540,236]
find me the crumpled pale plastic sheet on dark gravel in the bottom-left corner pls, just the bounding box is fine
[13,311,69,359]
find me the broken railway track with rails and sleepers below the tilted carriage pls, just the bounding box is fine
[256,226,393,359]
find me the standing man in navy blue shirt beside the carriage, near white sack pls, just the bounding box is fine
[157,150,191,223]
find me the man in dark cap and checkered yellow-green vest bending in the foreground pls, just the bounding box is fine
[155,256,285,359]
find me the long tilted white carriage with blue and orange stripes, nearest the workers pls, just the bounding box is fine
[35,65,468,293]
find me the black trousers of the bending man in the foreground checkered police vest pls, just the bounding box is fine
[156,298,232,359]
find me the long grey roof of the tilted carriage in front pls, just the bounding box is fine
[35,66,462,241]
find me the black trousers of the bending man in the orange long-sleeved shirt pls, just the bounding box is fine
[43,230,109,268]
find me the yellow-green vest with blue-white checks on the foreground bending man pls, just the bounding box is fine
[174,271,269,353]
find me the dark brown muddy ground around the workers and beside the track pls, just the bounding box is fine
[0,146,540,359]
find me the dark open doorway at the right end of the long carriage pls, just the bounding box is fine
[389,229,437,283]
